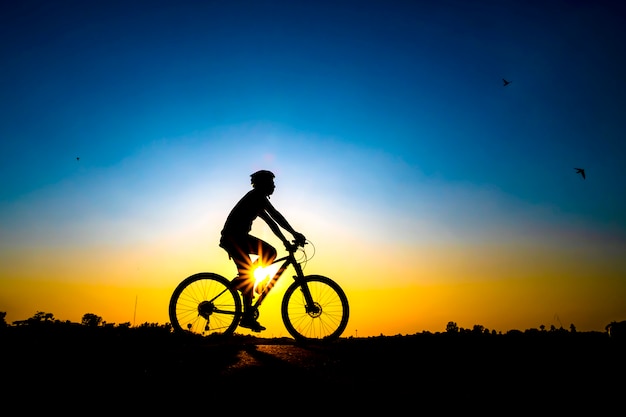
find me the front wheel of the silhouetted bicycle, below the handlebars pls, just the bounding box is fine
[281,275,350,341]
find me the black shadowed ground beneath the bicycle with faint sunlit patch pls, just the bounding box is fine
[0,326,626,415]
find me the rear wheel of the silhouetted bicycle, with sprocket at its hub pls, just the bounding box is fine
[169,272,241,336]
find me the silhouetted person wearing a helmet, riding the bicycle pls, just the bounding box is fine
[220,170,306,332]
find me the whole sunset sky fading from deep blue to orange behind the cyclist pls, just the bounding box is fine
[0,0,626,337]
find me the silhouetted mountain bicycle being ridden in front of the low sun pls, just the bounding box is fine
[169,241,350,341]
